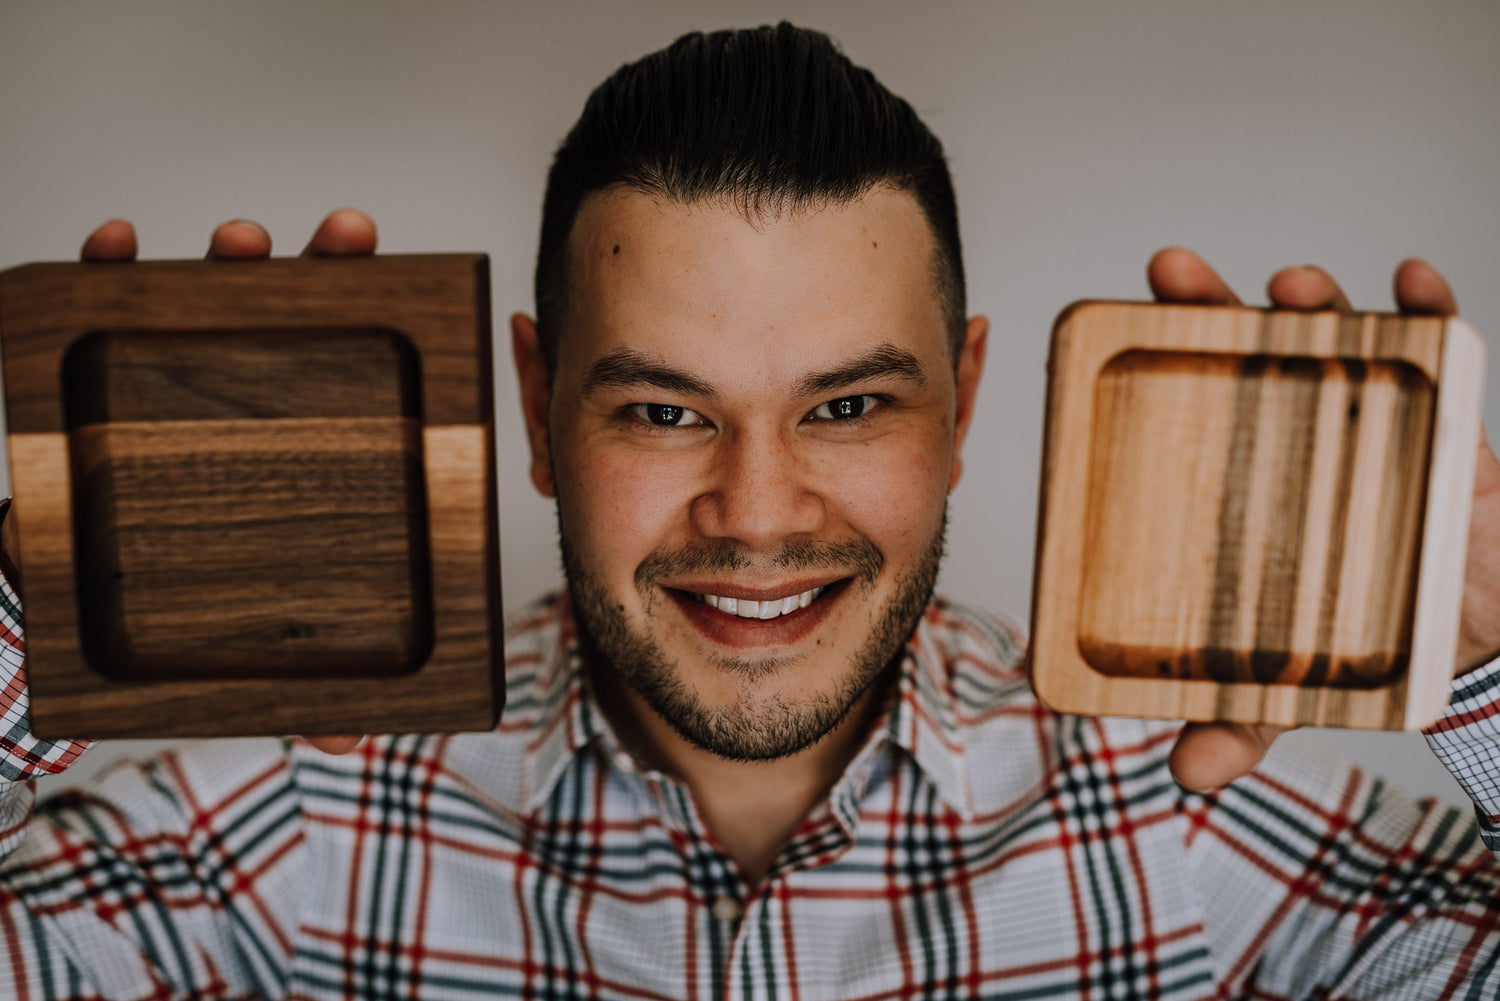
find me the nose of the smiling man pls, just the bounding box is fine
[692,432,827,549]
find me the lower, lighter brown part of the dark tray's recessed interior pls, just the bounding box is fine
[69,417,432,680]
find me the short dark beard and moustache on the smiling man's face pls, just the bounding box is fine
[558,510,948,761]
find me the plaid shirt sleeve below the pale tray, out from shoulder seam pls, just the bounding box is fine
[1184,729,1500,1001]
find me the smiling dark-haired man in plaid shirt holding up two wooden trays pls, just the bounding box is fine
[0,26,1500,998]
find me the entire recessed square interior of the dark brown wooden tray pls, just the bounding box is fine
[62,327,434,681]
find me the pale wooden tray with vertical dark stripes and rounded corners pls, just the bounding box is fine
[1031,302,1484,729]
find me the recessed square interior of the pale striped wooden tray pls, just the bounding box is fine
[1077,350,1434,687]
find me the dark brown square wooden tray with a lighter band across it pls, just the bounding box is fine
[0,254,504,738]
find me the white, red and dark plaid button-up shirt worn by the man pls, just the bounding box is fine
[0,570,1500,1001]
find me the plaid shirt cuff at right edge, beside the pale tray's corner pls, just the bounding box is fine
[1422,659,1500,852]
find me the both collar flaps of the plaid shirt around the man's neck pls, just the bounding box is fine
[516,593,974,818]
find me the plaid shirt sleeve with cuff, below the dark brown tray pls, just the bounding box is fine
[0,504,308,1001]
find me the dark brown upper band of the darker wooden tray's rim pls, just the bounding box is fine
[0,254,491,432]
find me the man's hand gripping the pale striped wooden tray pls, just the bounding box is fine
[1146,248,1500,789]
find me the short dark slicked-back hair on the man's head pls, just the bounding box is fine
[536,21,965,372]
